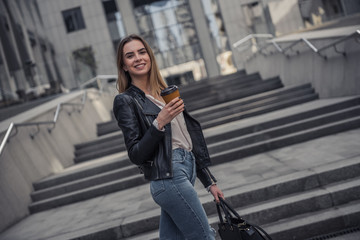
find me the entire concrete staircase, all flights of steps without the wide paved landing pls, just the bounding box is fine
[24,73,360,240]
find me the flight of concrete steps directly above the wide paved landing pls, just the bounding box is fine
[29,94,360,213]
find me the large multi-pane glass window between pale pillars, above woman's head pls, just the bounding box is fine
[133,0,202,69]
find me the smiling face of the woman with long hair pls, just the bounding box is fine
[123,40,151,80]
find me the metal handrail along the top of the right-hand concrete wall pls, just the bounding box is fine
[245,30,360,59]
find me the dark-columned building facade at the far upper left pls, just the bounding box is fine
[0,0,63,106]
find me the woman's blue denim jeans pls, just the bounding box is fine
[150,148,216,240]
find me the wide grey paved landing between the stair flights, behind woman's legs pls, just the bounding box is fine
[0,125,360,240]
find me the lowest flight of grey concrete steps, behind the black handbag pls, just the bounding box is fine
[121,157,360,240]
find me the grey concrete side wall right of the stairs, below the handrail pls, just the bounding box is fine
[245,34,360,98]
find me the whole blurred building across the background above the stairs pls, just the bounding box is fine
[0,0,360,106]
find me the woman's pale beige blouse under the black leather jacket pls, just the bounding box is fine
[146,94,192,152]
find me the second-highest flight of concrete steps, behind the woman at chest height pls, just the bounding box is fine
[74,84,318,163]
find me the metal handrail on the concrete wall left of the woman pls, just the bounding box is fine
[0,75,116,156]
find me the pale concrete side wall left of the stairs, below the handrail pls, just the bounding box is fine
[0,89,113,232]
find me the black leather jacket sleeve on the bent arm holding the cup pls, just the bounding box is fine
[113,94,165,165]
